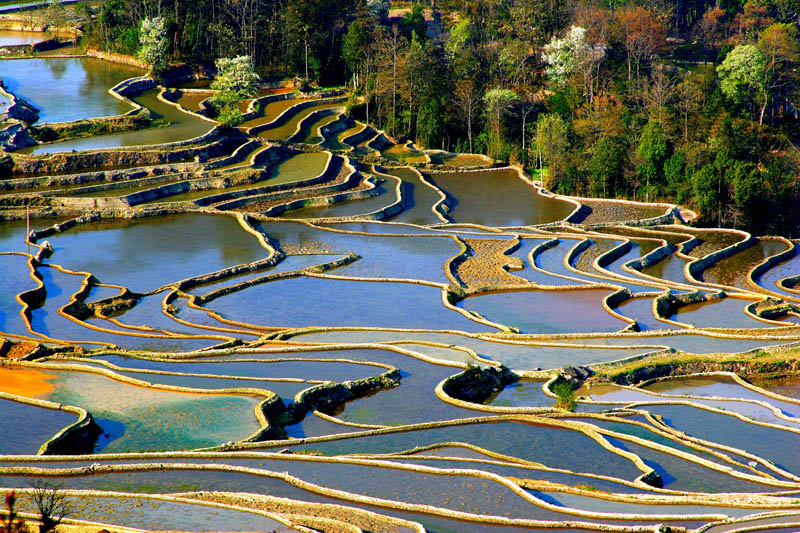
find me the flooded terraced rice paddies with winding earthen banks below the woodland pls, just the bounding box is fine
[0,50,800,533]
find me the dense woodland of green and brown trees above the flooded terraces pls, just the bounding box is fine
[79,0,800,236]
